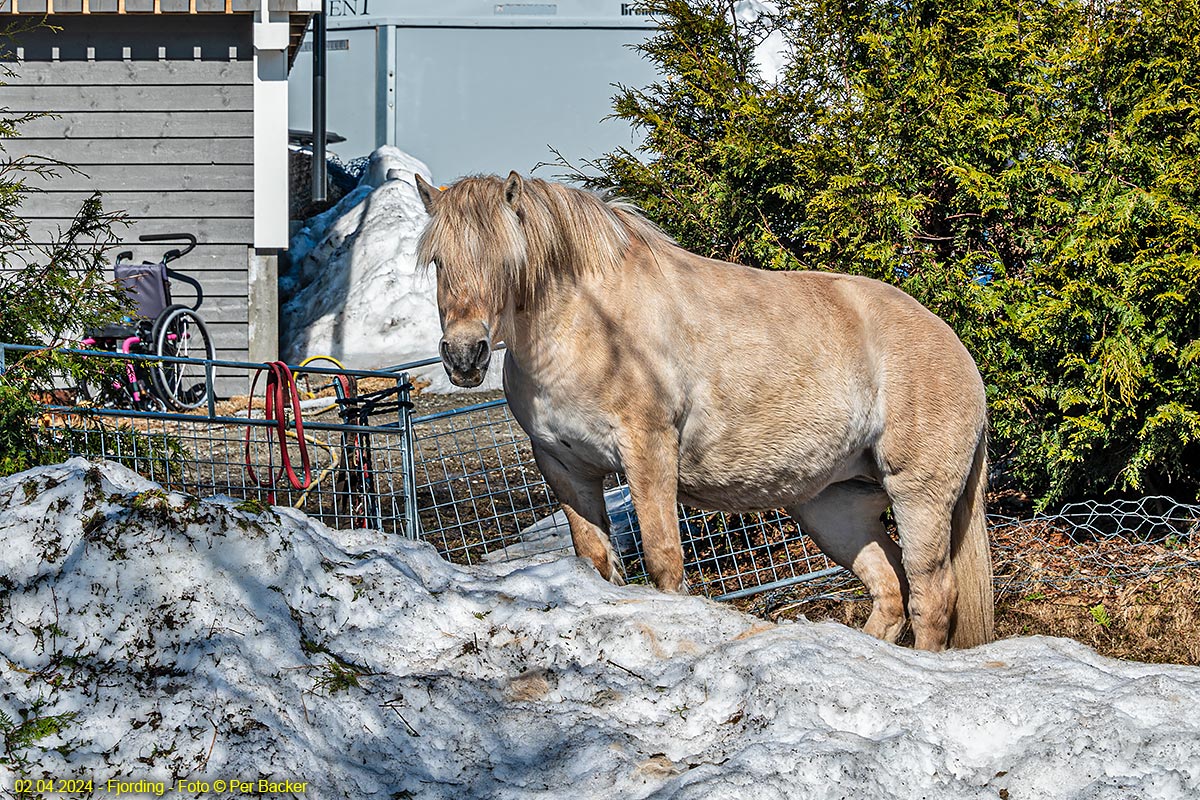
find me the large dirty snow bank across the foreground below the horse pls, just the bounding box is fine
[0,459,1200,800]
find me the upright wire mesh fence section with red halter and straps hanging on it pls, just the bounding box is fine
[11,345,413,534]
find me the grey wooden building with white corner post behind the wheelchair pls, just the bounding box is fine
[0,0,320,395]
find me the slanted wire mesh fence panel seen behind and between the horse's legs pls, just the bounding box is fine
[403,399,835,599]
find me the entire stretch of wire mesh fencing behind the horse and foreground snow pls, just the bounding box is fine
[0,345,1200,609]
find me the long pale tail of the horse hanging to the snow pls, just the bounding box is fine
[950,429,996,648]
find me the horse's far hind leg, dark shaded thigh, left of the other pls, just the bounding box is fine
[787,481,907,643]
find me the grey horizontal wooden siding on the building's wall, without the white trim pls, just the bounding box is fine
[0,16,253,393]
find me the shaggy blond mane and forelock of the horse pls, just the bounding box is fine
[416,175,677,303]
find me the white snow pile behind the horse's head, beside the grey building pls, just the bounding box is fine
[280,146,500,391]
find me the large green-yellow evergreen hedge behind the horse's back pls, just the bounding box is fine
[588,0,1200,506]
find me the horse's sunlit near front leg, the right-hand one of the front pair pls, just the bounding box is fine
[620,429,688,594]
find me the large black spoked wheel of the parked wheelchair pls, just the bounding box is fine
[150,306,212,411]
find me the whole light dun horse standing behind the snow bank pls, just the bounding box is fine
[418,173,992,650]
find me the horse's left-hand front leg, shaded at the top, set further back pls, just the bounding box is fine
[533,445,625,587]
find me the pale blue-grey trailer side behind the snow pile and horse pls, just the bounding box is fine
[288,0,655,182]
